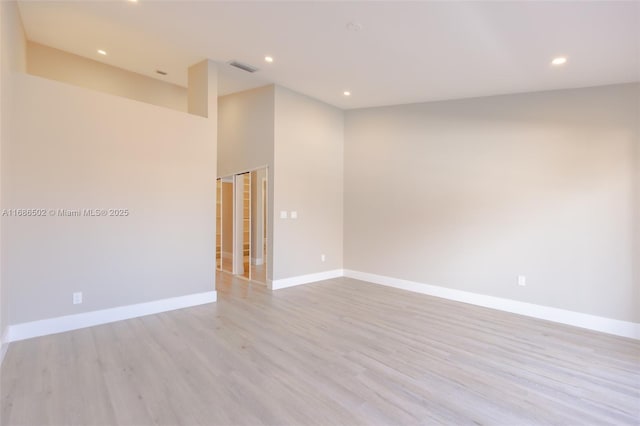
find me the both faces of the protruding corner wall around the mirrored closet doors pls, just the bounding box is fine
[218,86,344,281]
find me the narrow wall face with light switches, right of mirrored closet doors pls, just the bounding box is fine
[271,86,344,279]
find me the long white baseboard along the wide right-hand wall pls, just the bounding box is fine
[344,269,640,339]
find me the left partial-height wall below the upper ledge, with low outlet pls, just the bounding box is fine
[2,75,216,324]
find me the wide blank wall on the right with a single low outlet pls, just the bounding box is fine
[344,84,640,322]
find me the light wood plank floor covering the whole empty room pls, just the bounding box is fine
[1,276,640,425]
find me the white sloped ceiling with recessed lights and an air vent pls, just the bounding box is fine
[19,0,640,109]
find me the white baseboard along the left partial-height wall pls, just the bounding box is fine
[3,291,217,343]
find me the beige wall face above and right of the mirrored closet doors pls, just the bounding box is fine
[218,86,275,279]
